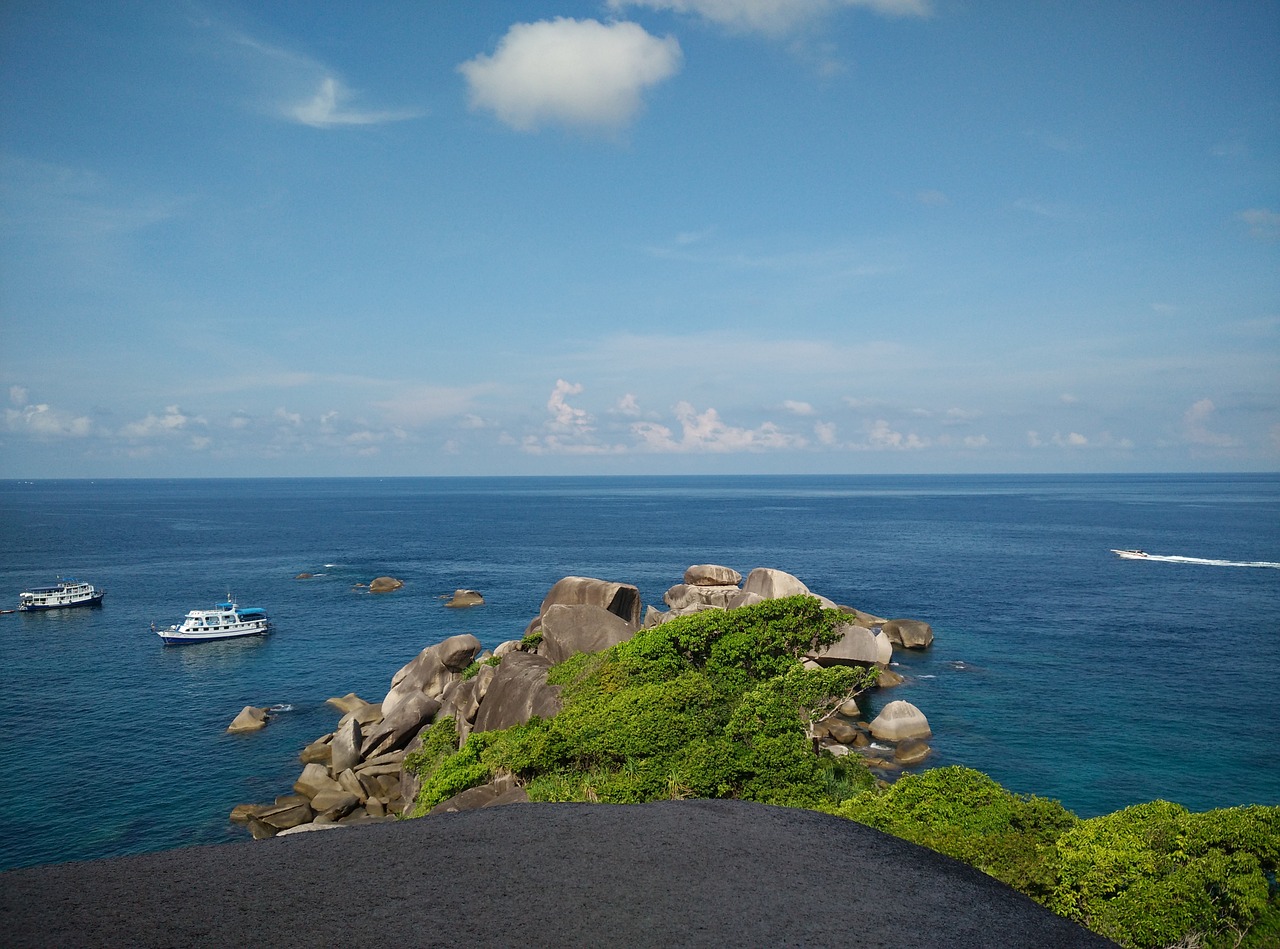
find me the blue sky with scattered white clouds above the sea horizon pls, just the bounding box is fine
[0,0,1280,478]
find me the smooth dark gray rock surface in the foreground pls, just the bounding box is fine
[0,800,1111,949]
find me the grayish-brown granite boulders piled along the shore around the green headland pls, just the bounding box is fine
[228,564,933,839]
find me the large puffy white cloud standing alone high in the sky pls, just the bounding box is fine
[458,17,682,132]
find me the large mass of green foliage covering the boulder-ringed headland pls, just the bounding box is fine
[406,597,874,813]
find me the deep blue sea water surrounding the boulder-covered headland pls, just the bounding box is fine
[0,475,1280,868]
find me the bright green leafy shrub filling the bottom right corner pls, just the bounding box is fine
[1048,800,1280,949]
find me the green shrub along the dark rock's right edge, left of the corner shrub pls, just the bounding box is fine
[836,766,1078,903]
